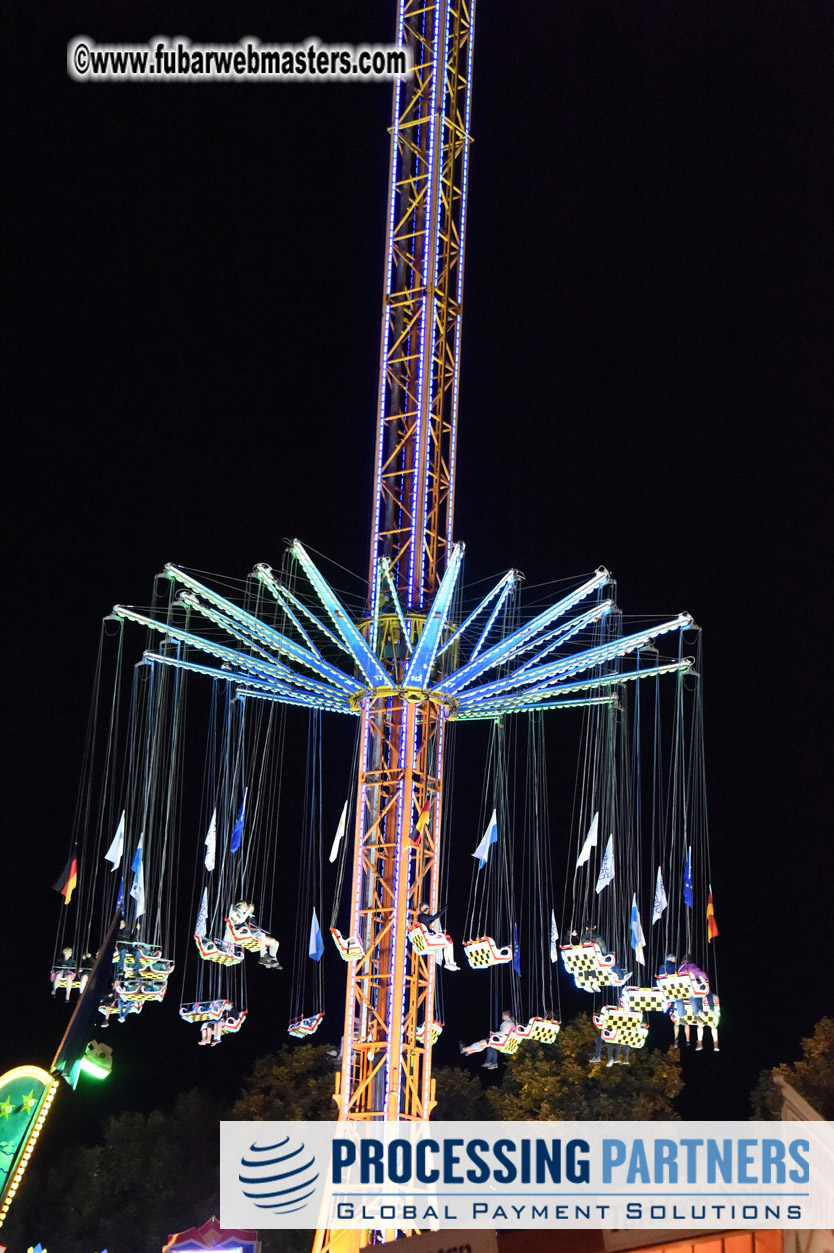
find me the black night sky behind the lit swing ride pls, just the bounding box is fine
[0,0,834,1134]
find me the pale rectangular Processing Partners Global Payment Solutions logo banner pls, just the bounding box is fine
[220,1121,834,1232]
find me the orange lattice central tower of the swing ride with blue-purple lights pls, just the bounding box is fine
[339,0,475,1119]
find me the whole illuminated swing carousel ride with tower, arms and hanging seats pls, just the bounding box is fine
[3,0,719,1249]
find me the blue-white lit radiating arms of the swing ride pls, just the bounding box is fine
[113,540,694,722]
